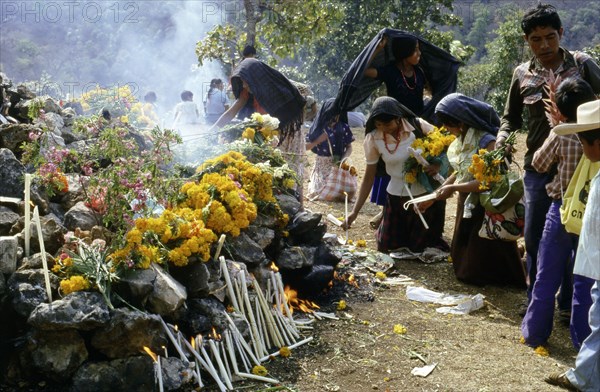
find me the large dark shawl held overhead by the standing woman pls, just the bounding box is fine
[332,29,460,125]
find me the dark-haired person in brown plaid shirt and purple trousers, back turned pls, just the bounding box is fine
[521,78,596,349]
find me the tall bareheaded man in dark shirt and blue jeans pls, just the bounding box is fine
[496,4,600,315]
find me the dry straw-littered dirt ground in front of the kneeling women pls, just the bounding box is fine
[250,129,577,392]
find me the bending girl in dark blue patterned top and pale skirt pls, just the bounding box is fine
[306,98,354,200]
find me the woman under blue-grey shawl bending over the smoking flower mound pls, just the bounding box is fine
[211,58,306,202]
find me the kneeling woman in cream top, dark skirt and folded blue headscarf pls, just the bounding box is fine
[435,93,525,288]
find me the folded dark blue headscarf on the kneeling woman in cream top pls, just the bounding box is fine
[435,93,500,135]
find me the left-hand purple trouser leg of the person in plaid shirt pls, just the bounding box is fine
[521,200,589,347]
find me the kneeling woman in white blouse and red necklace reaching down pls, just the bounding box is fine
[343,97,448,252]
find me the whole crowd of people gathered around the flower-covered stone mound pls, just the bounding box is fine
[137,4,600,392]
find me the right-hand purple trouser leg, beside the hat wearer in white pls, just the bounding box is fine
[570,275,595,350]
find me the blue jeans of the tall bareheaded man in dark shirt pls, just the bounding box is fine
[523,170,552,301]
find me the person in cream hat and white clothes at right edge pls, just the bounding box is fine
[545,100,600,392]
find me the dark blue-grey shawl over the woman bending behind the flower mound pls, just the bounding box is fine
[231,58,306,141]
